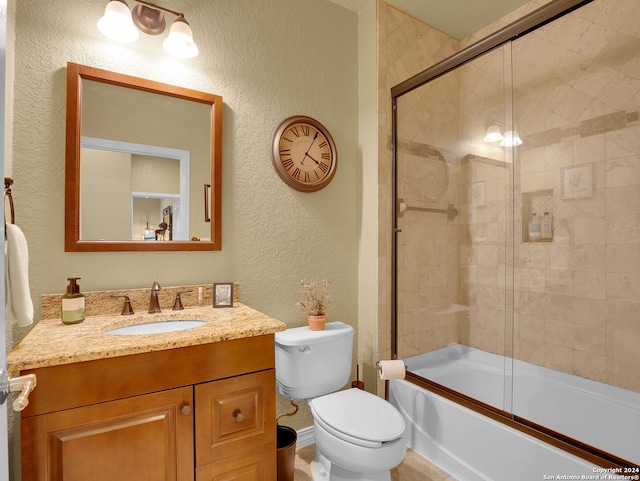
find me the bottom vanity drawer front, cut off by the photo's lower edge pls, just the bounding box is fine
[196,444,276,481]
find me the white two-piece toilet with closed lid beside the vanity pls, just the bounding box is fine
[275,322,406,481]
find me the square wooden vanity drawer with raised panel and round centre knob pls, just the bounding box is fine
[195,369,276,466]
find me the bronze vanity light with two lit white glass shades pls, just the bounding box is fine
[98,0,199,58]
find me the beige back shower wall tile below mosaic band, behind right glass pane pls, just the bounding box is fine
[515,119,640,390]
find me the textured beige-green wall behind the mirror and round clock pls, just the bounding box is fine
[7,0,360,472]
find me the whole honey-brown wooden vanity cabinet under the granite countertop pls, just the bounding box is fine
[21,334,276,481]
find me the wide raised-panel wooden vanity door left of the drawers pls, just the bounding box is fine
[22,387,194,481]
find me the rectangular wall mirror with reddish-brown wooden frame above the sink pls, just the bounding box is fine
[65,63,222,252]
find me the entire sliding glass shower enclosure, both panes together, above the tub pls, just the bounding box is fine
[395,0,640,464]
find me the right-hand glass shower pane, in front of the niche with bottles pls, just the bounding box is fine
[513,0,640,464]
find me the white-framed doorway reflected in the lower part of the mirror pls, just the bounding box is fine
[80,137,190,241]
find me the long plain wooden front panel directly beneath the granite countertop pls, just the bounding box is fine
[21,334,275,418]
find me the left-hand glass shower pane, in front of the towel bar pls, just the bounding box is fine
[396,41,514,410]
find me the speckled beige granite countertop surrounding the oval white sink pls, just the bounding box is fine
[7,303,287,376]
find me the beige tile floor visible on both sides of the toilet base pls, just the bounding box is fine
[294,444,456,481]
